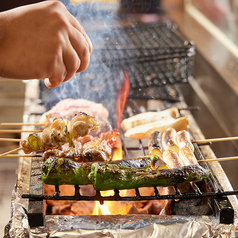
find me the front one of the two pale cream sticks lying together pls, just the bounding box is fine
[125,117,188,140]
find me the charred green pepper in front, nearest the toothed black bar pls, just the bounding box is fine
[89,163,209,190]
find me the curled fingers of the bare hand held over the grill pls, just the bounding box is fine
[41,4,92,88]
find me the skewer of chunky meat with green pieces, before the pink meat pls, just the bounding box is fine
[21,113,100,154]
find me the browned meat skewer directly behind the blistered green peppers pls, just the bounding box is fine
[42,130,119,162]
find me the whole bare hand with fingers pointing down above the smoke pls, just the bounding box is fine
[0,1,92,88]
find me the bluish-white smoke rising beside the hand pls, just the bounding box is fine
[41,0,123,122]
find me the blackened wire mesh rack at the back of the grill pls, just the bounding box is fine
[89,23,195,89]
